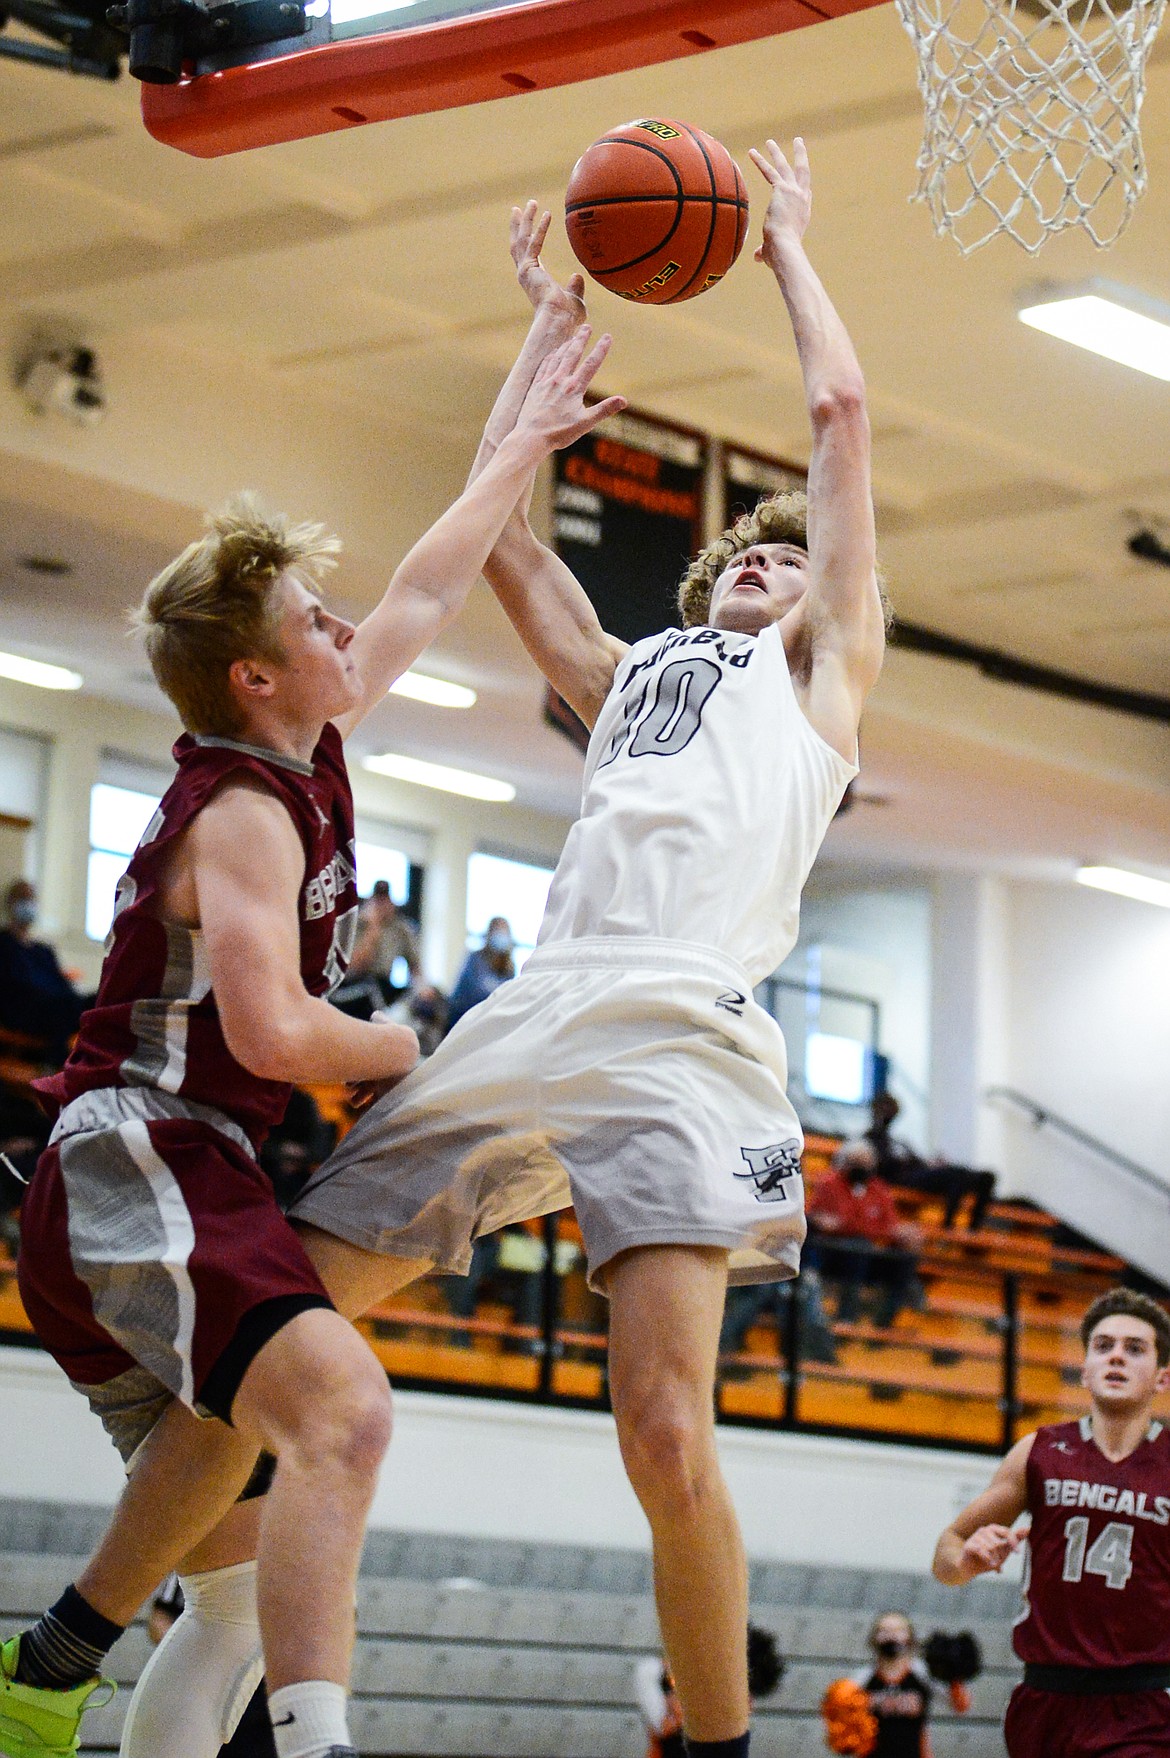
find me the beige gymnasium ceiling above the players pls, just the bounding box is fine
[0,5,1170,874]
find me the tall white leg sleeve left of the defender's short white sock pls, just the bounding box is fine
[119,1563,264,1758]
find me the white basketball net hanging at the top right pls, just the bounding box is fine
[896,0,1166,255]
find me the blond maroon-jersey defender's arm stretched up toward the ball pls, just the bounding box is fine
[337,325,625,737]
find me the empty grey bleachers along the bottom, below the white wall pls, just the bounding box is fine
[0,1501,1017,1758]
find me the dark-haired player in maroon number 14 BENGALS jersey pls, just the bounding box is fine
[935,1289,1170,1758]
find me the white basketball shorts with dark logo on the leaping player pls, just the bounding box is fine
[292,939,805,1292]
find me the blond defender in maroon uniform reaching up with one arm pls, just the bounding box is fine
[0,327,624,1758]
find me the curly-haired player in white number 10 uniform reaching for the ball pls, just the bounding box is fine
[72,141,884,1758]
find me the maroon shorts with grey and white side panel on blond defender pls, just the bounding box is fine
[19,1086,332,1463]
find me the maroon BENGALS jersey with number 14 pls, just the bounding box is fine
[1014,1417,1170,1668]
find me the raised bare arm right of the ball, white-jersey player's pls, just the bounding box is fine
[752,139,885,716]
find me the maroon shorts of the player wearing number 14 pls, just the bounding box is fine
[1003,1684,1170,1758]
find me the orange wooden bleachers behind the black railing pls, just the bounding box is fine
[0,1208,1121,1452]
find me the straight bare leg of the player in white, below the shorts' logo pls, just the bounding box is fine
[608,1245,748,1740]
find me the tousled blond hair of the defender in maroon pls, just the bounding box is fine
[130,494,341,738]
